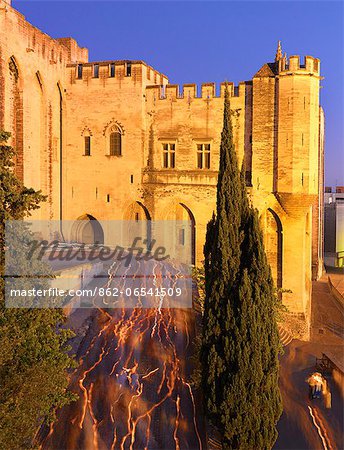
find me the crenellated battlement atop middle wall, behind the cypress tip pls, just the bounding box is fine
[146,81,246,100]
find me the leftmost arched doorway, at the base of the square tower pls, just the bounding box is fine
[71,214,104,244]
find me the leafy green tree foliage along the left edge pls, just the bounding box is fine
[0,131,74,450]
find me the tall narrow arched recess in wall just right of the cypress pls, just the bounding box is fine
[265,208,283,289]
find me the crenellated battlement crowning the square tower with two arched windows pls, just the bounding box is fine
[67,60,168,85]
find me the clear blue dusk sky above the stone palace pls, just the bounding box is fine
[12,0,344,186]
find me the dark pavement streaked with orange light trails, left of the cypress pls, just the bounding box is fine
[40,256,204,450]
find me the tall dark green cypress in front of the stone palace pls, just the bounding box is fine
[201,89,281,450]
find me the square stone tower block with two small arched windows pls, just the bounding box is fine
[63,61,167,220]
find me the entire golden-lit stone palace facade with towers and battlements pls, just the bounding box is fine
[0,0,324,324]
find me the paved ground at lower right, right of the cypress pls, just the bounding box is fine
[274,273,344,450]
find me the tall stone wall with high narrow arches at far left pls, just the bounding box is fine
[0,0,88,219]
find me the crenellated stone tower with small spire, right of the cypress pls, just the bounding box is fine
[252,43,324,322]
